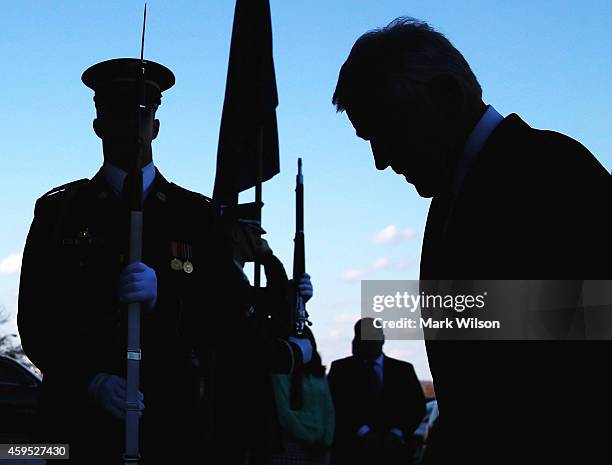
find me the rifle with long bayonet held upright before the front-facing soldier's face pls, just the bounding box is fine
[123,3,147,465]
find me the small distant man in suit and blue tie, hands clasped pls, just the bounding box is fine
[328,318,425,465]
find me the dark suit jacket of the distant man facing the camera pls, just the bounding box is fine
[328,355,425,463]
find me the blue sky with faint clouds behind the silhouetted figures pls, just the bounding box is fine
[0,0,612,378]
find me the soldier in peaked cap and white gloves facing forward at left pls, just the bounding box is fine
[18,58,251,464]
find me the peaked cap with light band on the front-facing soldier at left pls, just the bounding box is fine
[81,58,175,106]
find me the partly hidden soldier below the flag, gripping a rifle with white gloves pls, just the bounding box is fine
[201,204,313,465]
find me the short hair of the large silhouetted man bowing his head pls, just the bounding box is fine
[332,17,482,112]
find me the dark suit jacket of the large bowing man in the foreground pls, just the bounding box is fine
[421,114,612,463]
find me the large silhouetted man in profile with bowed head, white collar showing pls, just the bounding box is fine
[333,18,612,463]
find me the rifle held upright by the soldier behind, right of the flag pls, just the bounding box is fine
[289,158,312,410]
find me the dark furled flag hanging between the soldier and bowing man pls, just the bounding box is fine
[213,0,280,203]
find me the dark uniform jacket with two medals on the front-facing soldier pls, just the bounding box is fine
[18,172,251,464]
